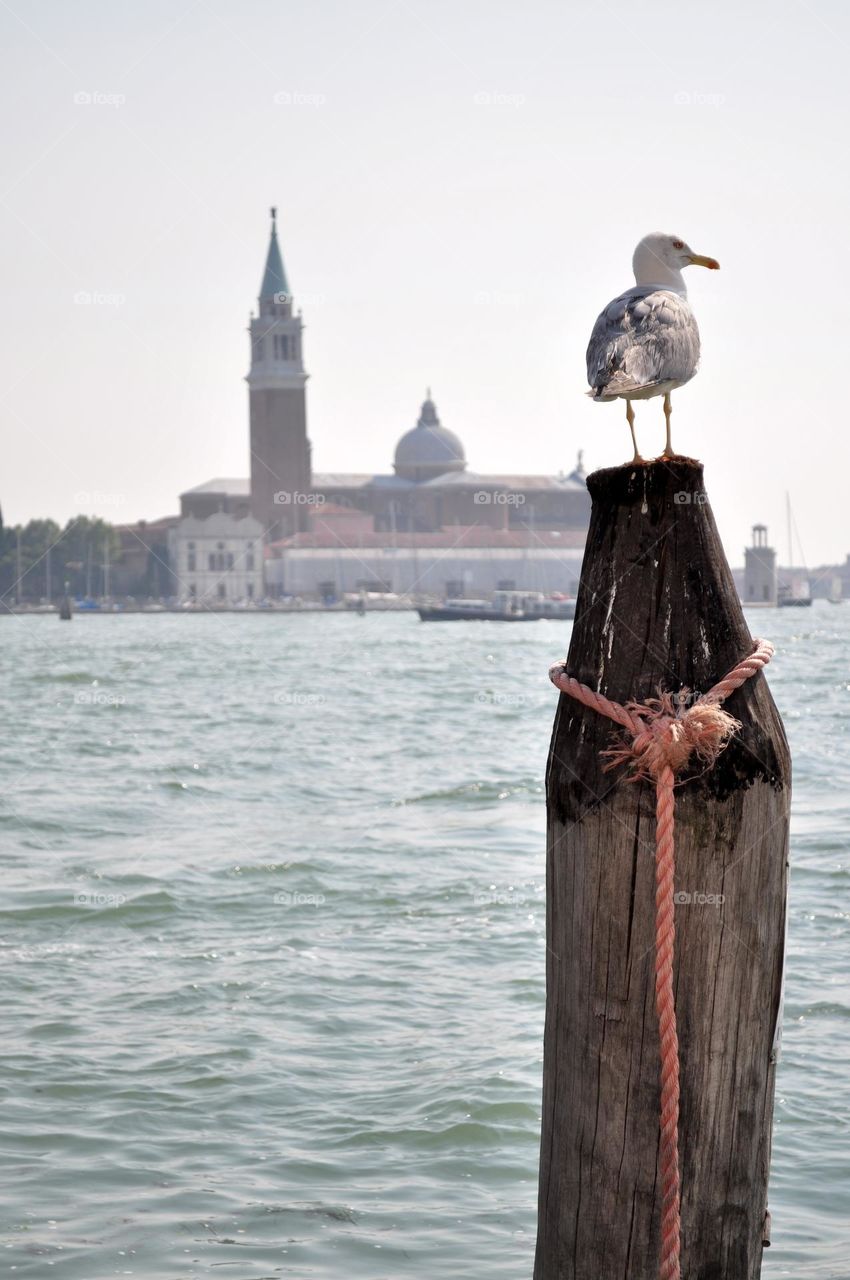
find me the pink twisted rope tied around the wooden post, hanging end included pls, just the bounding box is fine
[549,640,773,1280]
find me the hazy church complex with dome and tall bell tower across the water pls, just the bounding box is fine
[169,210,590,603]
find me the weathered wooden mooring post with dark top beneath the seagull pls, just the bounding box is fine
[534,458,790,1280]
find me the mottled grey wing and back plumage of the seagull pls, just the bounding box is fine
[588,289,699,396]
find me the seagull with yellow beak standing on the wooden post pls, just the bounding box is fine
[588,232,719,462]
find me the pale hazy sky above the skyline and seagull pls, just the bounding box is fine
[0,0,850,564]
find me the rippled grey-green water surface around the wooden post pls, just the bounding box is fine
[0,614,850,1280]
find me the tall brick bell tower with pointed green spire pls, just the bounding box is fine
[246,209,312,541]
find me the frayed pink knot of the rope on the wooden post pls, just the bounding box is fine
[602,690,740,782]
